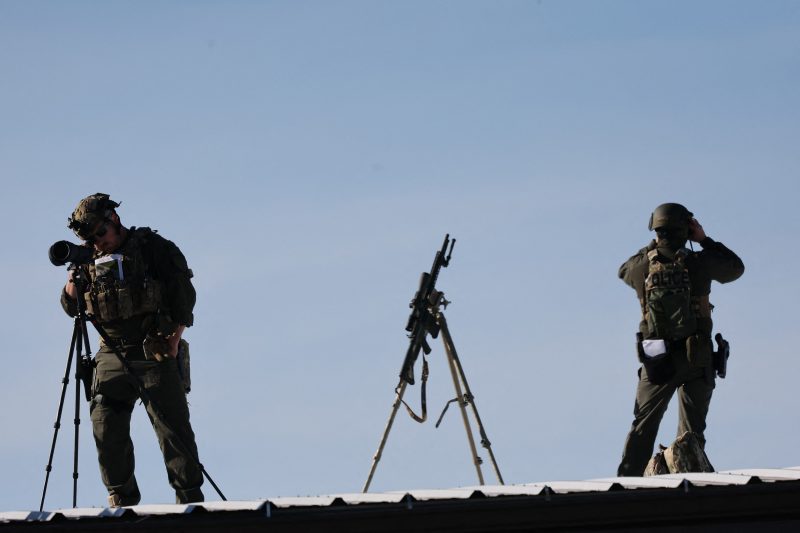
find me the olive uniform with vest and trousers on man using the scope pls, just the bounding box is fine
[61,224,203,505]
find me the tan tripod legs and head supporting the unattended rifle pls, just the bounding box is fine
[362,291,504,492]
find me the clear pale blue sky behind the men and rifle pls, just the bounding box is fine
[0,0,800,510]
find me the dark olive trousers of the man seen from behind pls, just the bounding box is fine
[617,344,714,476]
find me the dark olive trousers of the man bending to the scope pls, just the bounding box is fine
[89,345,203,505]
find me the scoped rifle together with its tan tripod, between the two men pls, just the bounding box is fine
[362,235,504,492]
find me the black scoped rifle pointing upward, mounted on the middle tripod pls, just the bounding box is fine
[400,233,456,385]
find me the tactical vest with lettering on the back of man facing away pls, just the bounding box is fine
[641,249,696,341]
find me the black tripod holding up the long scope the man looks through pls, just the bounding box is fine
[39,265,93,512]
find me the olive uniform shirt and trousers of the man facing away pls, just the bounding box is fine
[617,237,744,476]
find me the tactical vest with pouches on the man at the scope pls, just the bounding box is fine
[84,228,161,322]
